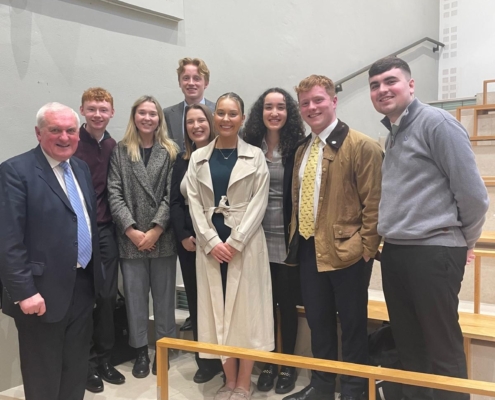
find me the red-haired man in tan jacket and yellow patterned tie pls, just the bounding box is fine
[284,75,382,400]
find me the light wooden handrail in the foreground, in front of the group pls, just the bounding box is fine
[156,338,495,400]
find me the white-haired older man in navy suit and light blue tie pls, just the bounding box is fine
[0,103,104,400]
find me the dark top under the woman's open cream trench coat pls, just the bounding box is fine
[210,149,237,242]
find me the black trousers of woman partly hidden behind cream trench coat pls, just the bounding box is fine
[177,243,222,370]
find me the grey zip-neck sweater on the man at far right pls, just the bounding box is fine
[378,99,488,248]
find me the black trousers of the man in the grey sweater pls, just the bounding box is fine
[381,243,469,400]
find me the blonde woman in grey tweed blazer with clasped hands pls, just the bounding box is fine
[108,96,178,378]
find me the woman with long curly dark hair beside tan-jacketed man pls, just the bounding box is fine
[244,88,304,394]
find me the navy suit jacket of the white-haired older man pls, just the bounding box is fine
[0,146,104,322]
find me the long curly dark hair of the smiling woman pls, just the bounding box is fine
[243,88,305,164]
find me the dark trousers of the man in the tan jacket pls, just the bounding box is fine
[299,237,373,398]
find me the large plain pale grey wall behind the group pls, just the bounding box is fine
[0,0,439,391]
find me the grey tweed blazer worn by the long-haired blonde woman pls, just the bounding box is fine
[108,142,176,259]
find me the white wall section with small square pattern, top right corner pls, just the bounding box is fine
[438,0,495,99]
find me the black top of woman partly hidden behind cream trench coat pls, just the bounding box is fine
[170,152,196,242]
